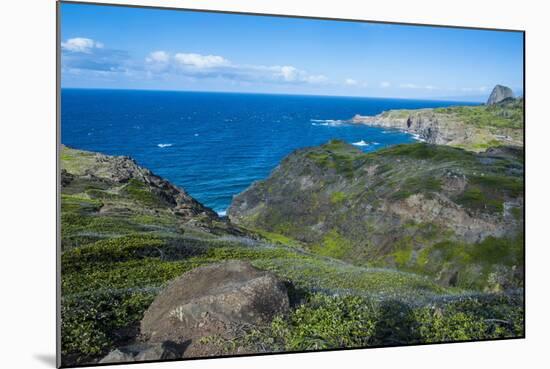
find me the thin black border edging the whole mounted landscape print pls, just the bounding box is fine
[55,0,527,368]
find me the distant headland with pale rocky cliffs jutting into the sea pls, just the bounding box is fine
[351,99,523,152]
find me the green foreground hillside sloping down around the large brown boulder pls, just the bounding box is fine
[61,147,523,365]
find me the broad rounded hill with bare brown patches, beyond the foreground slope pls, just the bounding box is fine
[228,140,523,286]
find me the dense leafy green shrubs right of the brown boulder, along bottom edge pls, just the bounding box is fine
[205,293,524,353]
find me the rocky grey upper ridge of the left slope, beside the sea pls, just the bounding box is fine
[61,146,247,239]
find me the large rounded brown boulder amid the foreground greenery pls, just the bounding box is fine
[141,261,289,343]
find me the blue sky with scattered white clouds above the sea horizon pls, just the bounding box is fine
[61,3,523,101]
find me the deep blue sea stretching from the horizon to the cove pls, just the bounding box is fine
[61,89,472,212]
